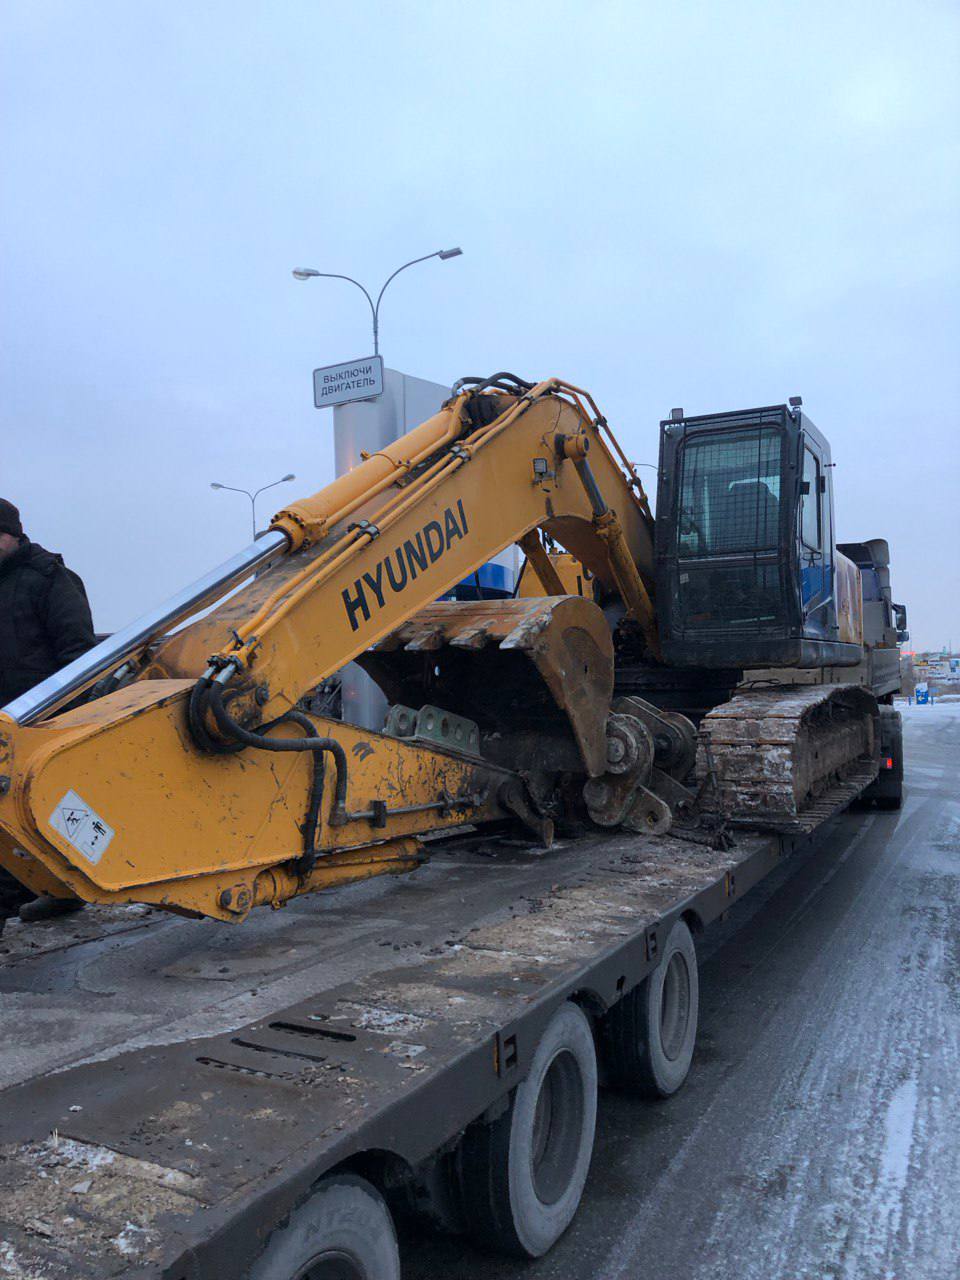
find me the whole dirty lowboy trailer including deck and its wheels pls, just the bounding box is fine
[0,832,849,1280]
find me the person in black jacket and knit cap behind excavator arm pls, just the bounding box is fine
[0,498,95,919]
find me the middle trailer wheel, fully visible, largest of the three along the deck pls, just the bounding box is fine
[453,1002,596,1258]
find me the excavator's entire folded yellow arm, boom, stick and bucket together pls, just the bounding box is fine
[0,375,690,920]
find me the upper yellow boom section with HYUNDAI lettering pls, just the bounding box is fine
[151,379,659,718]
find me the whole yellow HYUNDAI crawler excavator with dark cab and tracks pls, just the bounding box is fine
[0,374,904,922]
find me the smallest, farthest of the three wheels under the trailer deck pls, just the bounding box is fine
[600,920,700,1098]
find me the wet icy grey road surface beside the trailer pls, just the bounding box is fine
[403,703,960,1280]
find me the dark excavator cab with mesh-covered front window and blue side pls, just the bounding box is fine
[657,397,861,668]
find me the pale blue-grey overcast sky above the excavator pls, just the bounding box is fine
[0,0,960,648]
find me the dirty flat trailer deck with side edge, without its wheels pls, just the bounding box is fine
[0,833,792,1280]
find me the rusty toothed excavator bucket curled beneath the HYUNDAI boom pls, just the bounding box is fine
[357,595,613,777]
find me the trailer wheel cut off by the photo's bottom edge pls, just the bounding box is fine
[250,1175,401,1280]
